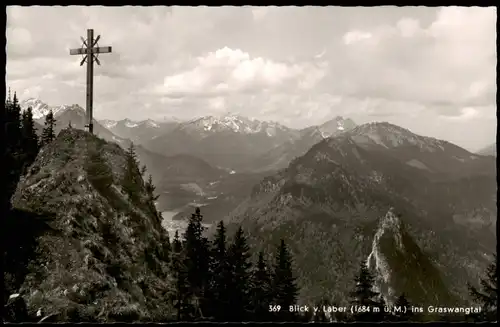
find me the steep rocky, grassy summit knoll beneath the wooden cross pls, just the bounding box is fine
[8,129,175,322]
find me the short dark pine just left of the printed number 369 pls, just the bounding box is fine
[251,251,273,321]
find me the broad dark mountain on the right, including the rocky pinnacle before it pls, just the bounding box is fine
[226,123,496,306]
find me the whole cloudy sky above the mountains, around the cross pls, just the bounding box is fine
[6,6,497,150]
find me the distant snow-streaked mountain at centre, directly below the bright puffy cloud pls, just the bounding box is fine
[145,114,299,171]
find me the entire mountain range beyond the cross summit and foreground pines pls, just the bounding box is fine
[18,96,497,312]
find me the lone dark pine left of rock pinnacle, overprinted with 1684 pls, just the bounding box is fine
[351,262,379,322]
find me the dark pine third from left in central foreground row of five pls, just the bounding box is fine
[228,226,252,321]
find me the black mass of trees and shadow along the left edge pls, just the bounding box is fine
[1,90,56,316]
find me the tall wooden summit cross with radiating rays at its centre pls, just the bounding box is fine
[69,29,111,133]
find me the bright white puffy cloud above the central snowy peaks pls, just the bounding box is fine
[155,47,324,97]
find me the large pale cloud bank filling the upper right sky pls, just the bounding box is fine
[339,7,496,114]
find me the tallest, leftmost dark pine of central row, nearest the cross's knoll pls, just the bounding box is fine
[183,208,210,319]
